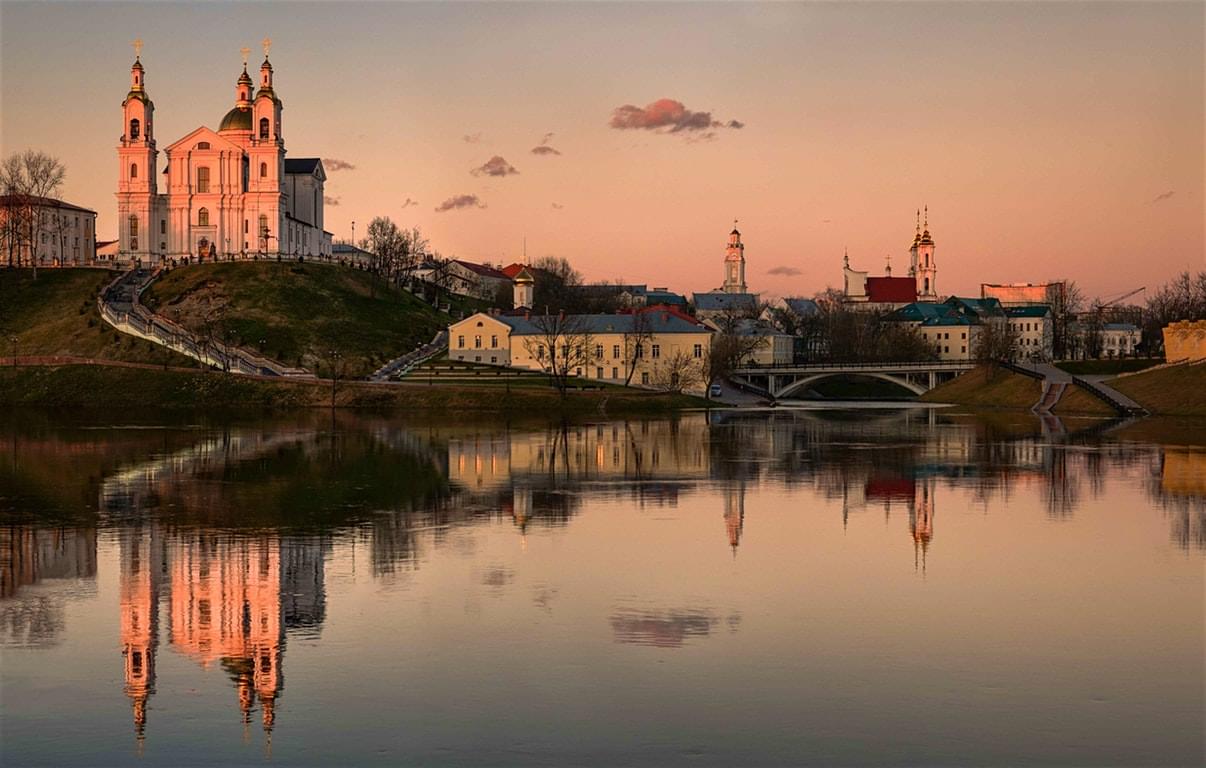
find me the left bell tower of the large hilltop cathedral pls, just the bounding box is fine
[117,40,159,263]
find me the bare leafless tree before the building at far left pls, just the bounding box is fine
[0,150,66,280]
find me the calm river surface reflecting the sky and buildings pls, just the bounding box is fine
[0,411,1206,766]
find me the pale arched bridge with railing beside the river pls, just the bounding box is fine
[732,360,976,400]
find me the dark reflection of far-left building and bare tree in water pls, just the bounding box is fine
[0,524,96,645]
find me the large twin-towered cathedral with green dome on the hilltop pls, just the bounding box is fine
[117,40,332,266]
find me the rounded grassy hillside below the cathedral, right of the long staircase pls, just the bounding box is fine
[144,262,449,376]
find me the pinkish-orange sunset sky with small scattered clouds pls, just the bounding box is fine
[0,0,1206,298]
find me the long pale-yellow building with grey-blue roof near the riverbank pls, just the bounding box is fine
[449,307,713,389]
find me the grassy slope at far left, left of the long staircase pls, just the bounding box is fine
[0,269,193,365]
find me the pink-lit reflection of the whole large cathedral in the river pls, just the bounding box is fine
[121,526,326,743]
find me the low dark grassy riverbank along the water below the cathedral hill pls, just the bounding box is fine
[0,364,708,414]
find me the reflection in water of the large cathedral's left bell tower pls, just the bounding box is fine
[118,528,163,748]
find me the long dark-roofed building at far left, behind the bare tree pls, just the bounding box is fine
[0,194,96,266]
